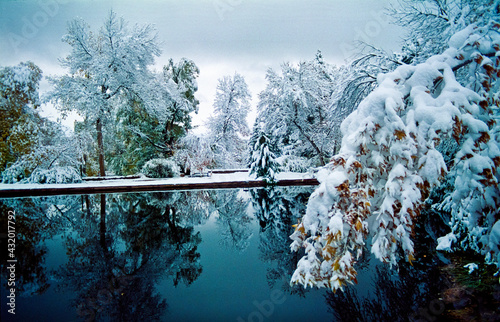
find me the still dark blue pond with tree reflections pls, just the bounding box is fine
[0,187,450,321]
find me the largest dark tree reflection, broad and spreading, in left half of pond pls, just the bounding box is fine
[57,193,208,321]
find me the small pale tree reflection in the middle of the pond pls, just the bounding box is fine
[214,190,252,251]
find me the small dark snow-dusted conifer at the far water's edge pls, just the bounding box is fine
[250,131,279,183]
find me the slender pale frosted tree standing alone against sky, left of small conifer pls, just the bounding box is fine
[208,73,251,168]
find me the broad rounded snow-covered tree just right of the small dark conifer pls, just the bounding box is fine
[258,52,335,165]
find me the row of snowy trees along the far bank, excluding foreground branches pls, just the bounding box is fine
[0,11,362,183]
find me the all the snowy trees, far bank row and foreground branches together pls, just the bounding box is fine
[0,0,500,290]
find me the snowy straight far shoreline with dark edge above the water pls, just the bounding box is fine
[0,172,319,198]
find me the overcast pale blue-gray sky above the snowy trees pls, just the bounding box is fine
[0,0,402,131]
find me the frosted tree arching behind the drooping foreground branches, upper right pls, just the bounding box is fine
[331,0,499,158]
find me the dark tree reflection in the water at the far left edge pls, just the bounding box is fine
[0,196,78,296]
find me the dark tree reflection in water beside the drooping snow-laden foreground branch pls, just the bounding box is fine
[250,187,311,296]
